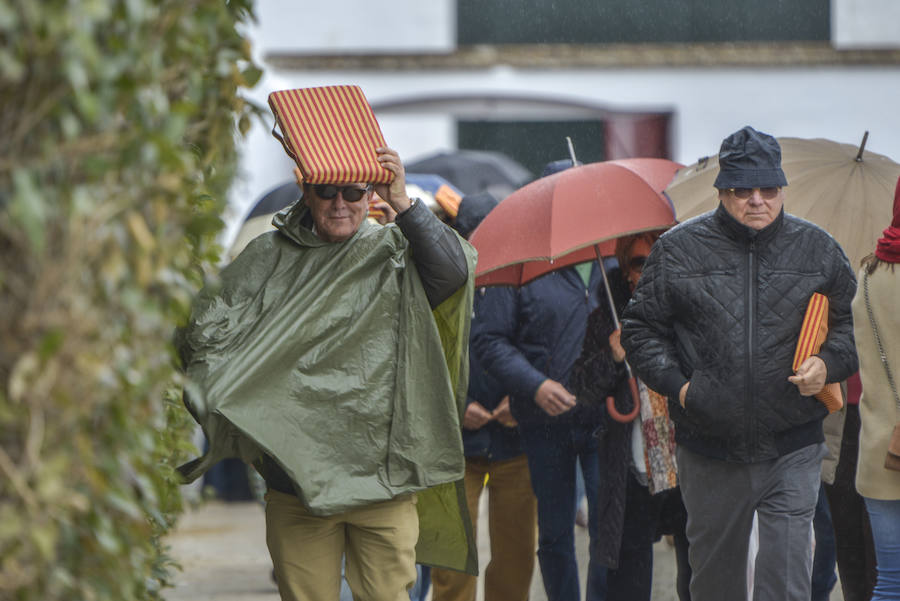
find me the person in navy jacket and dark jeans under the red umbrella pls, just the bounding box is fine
[471,161,606,601]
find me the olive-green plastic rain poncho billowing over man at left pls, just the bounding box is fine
[176,203,477,573]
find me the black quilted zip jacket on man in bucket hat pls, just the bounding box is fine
[622,205,857,463]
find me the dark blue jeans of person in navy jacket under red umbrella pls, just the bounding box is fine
[519,420,606,601]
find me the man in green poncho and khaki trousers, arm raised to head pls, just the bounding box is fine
[177,148,475,601]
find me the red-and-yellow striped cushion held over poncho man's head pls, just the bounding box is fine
[269,86,394,184]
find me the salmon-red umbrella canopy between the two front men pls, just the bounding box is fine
[470,159,680,286]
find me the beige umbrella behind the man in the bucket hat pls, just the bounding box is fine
[665,132,900,269]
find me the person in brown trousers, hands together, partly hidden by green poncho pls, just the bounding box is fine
[432,192,537,601]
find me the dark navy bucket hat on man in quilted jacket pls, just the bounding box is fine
[713,125,787,190]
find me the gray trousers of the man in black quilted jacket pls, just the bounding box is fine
[676,444,825,601]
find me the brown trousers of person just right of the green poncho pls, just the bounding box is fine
[431,454,537,601]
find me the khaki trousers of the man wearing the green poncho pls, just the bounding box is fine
[266,490,419,601]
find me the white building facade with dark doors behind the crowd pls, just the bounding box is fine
[223,0,900,244]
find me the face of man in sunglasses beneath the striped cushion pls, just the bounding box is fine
[304,184,372,242]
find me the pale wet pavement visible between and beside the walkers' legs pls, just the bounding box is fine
[165,497,696,601]
